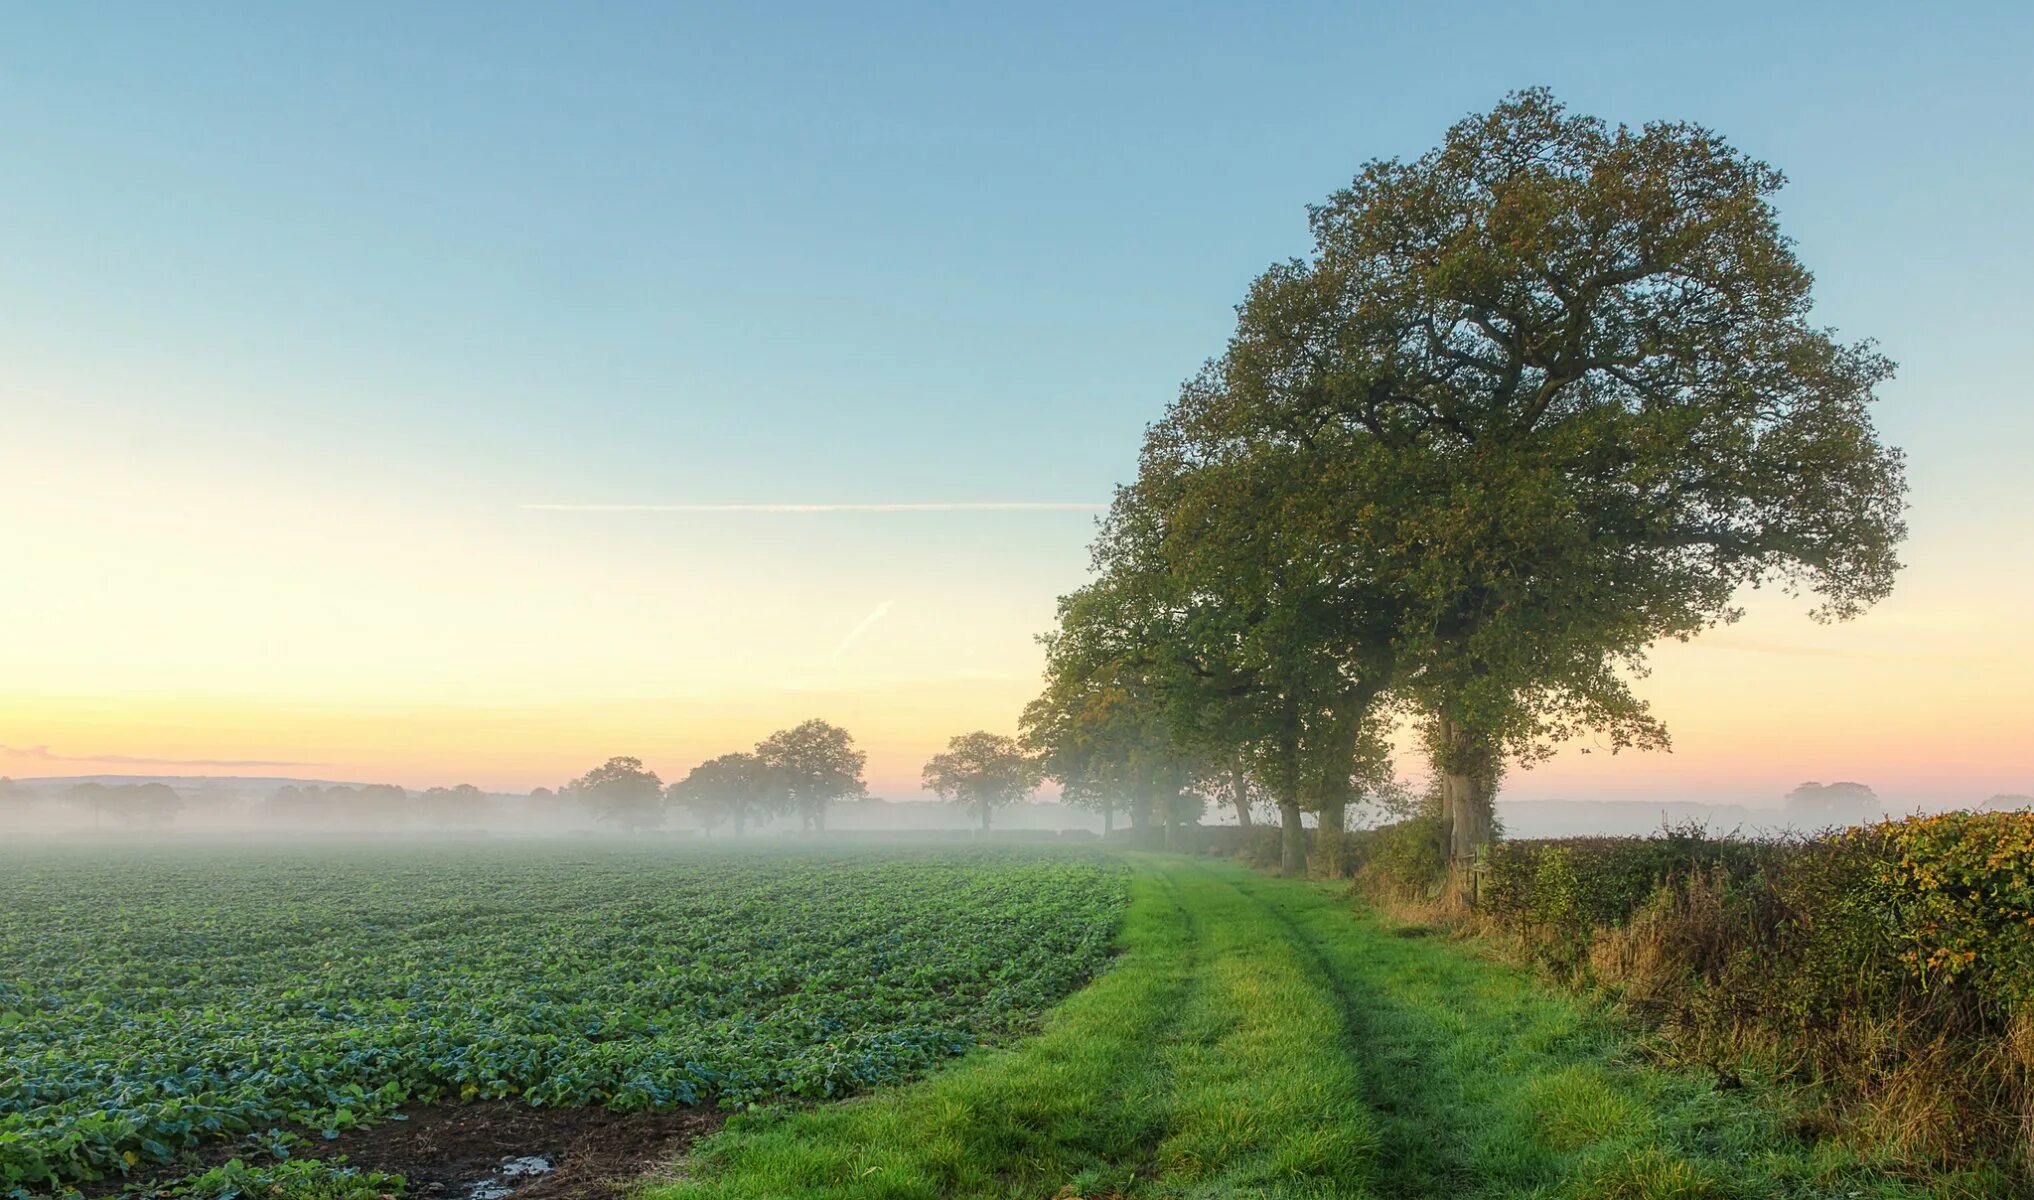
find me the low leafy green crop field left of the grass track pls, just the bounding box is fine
[0,844,1127,1196]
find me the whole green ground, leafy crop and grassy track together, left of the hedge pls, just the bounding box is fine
[0,842,2024,1200]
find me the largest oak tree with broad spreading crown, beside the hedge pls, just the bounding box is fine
[1198,92,1904,856]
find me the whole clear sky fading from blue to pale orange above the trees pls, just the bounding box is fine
[0,2,2034,803]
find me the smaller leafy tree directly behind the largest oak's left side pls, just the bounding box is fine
[1027,469,1399,875]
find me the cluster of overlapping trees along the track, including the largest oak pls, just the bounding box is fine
[1023,92,1904,873]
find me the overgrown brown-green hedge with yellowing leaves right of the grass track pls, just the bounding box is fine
[1448,812,2034,1165]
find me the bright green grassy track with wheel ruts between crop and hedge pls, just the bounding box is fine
[649,856,1987,1200]
